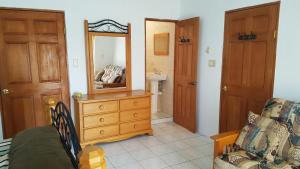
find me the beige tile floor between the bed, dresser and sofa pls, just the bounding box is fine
[99,122,213,169]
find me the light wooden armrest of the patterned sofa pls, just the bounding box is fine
[210,131,240,158]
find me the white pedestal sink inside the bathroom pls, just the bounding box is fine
[146,73,167,113]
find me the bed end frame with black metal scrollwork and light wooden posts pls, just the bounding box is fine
[48,99,106,169]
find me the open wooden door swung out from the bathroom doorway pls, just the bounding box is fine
[174,17,199,132]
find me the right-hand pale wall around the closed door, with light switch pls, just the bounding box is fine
[180,0,300,135]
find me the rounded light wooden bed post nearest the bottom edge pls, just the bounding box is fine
[78,146,106,169]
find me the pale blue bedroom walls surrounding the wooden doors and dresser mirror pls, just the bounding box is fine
[0,0,300,139]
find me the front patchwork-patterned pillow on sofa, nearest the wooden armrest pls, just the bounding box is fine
[235,112,289,161]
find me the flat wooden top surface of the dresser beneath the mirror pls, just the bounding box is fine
[75,90,151,102]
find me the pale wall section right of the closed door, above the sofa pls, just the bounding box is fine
[274,0,300,102]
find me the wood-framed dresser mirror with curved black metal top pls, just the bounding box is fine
[84,19,131,94]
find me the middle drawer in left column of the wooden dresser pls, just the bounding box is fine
[83,113,119,128]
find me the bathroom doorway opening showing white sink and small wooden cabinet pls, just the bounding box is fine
[145,18,176,123]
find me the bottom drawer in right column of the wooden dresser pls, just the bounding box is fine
[120,120,151,134]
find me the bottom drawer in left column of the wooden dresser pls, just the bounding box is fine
[83,125,119,141]
